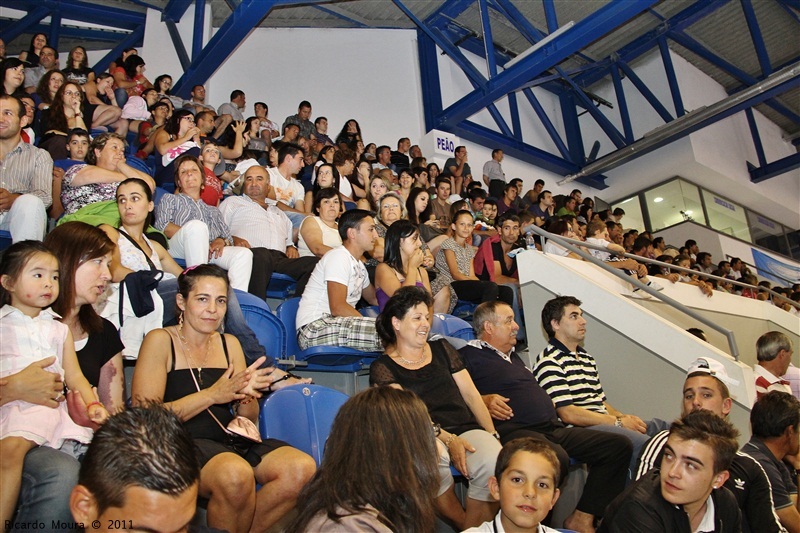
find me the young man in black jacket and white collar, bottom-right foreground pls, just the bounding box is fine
[598,409,742,533]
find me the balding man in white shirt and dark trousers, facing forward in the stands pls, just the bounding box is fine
[219,166,319,299]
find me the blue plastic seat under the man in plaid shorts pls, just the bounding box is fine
[275,298,380,372]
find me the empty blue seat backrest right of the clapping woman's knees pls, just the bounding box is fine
[258,385,348,465]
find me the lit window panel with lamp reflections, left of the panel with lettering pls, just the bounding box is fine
[644,179,706,231]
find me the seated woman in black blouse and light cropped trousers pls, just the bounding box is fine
[369,287,501,530]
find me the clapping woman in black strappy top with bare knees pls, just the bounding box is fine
[132,264,315,532]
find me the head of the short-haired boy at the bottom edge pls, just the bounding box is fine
[489,451,559,532]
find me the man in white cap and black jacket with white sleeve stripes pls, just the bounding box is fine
[636,357,785,533]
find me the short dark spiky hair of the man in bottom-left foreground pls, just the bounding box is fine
[78,404,200,514]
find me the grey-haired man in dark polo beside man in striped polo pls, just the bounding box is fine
[459,301,632,531]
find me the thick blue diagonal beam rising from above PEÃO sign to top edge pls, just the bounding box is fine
[438,0,657,125]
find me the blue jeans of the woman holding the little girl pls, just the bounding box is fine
[11,446,80,531]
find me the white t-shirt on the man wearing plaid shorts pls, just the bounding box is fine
[296,246,369,330]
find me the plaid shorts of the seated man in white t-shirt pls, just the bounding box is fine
[297,315,383,352]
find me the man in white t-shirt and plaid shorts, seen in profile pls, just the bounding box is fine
[297,209,383,352]
